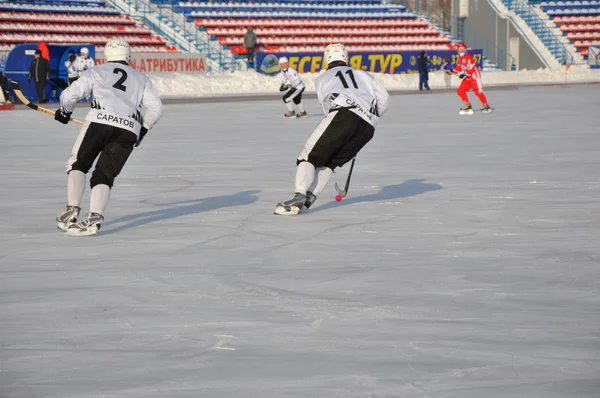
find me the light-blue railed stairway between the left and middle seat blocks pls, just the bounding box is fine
[108,0,243,72]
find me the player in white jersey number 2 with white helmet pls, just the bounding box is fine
[54,39,163,236]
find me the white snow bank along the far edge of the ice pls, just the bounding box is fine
[150,66,600,98]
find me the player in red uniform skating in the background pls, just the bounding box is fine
[453,43,492,115]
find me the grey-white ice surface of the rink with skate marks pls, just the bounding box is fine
[0,85,600,398]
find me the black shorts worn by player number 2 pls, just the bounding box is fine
[67,123,137,188]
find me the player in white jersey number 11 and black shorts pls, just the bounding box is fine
[275,44,390,215]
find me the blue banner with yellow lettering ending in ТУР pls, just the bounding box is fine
[256,50,483,75]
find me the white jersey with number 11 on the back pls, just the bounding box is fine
[315,66,390,127]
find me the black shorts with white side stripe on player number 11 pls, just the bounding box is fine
[297,108,375,170]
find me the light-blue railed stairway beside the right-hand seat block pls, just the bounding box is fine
[502,0,573,65]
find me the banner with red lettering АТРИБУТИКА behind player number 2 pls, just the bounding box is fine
[96,51,207,75]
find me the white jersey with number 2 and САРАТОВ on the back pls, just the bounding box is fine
[60,62,163,135]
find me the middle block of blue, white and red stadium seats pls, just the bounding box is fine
[177,0,451,55]
